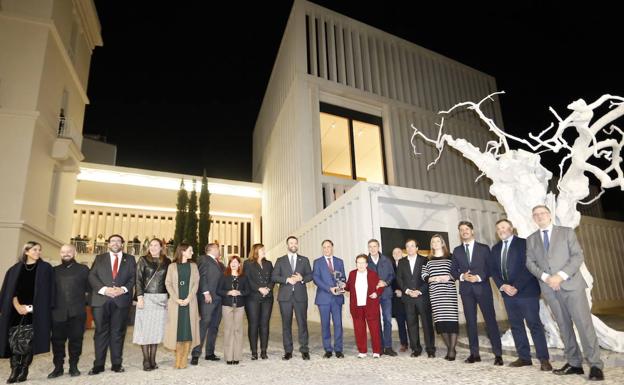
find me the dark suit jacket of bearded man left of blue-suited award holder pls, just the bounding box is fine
[271,254,312,302]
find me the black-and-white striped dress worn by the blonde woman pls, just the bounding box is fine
[422,257,459,333]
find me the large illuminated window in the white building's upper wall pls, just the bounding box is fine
[320,103,386,183]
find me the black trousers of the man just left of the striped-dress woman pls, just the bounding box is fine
[405,295,435,353]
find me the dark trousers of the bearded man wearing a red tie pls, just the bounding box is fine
[93,301,129,366]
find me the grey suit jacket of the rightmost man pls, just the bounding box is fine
[526,226,587,290]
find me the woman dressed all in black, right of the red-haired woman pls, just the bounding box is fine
[243,243,275,360]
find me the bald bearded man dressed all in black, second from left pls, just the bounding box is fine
[48,245,89,378]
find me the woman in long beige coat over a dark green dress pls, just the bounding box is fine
[163,243,199,369]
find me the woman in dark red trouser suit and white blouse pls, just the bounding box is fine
[345,254,384,358]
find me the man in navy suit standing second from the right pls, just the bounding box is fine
[490,219,552,371]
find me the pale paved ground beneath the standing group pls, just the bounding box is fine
[0,309,624,385]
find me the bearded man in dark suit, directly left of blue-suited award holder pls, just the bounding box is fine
[271,235,312,360]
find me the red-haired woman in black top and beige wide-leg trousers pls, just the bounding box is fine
[219,255,249,365]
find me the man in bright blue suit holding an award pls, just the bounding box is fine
[312,239,347,358]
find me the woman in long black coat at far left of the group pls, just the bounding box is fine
[0,241,54,384]
